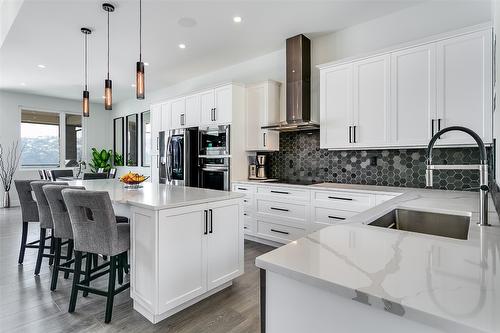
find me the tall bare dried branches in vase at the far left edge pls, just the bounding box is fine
[0,141,22,208]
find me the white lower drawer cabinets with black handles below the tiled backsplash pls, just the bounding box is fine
[233,183,398,244]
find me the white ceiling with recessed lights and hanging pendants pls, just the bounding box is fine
[0,0,422,102]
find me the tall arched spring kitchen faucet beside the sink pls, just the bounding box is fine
[425,126,490,226]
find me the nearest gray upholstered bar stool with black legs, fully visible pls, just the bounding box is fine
[62,189,130,323]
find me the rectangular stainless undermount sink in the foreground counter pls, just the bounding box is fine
[368,209,470,239]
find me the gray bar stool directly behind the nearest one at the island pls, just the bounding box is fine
[42,183,85,291]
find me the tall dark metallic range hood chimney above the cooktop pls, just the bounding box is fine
[262,35,319,132]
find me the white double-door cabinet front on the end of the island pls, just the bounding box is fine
[158,201,243,312]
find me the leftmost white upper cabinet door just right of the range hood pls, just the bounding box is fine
[320,64,353,148]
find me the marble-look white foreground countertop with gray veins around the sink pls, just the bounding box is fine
[256,188,500,332]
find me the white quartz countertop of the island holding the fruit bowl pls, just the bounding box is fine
[69,179,243,210]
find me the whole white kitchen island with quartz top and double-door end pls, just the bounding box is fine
[71,180,244,323]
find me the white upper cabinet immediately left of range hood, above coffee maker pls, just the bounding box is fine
[246,80,281,151]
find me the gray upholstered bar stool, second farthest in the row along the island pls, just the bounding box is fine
[30,180,68,275]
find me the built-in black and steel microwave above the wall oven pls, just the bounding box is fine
[198,125,230,157]
